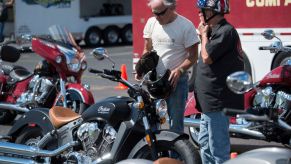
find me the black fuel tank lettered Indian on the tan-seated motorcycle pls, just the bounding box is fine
[82,96,133,126]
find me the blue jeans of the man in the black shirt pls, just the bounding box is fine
[198,112,230,164]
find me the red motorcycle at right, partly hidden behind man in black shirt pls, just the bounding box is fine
[184,30,291,147]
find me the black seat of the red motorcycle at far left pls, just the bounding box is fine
[3,65,33,84]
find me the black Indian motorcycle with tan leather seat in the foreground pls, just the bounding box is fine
[0,48,201,164]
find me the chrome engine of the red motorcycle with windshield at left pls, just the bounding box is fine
[16,75,54,106]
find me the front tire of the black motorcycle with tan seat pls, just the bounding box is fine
[128,140,201,164]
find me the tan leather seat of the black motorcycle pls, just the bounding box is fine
[49,106,81,128]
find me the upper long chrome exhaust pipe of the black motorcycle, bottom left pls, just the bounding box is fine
[0,141,79,157]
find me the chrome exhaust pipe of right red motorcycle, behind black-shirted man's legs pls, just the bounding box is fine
[184,118,266,139]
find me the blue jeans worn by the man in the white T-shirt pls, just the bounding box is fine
[167,74,188,133]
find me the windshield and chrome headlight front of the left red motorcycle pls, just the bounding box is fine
[49,25,85,72]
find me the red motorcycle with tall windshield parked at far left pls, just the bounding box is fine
[0,25,94,124]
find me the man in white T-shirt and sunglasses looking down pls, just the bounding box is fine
[136,0,199,132]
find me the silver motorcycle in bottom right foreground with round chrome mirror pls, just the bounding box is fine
[224,104,291,164]
